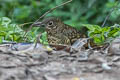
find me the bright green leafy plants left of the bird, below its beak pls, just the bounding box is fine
[0,17,48,44]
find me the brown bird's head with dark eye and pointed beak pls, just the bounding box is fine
[34,17,61,29]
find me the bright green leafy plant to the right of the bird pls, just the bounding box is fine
[83,24,120,45]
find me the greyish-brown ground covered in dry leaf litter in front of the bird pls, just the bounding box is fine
[0,38,120,80]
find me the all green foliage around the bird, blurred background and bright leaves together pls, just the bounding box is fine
[0,0,120,44]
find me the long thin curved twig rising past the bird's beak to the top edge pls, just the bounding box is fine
[23,0,72,41]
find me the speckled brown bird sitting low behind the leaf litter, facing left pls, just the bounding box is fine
[34,17,86,45]
